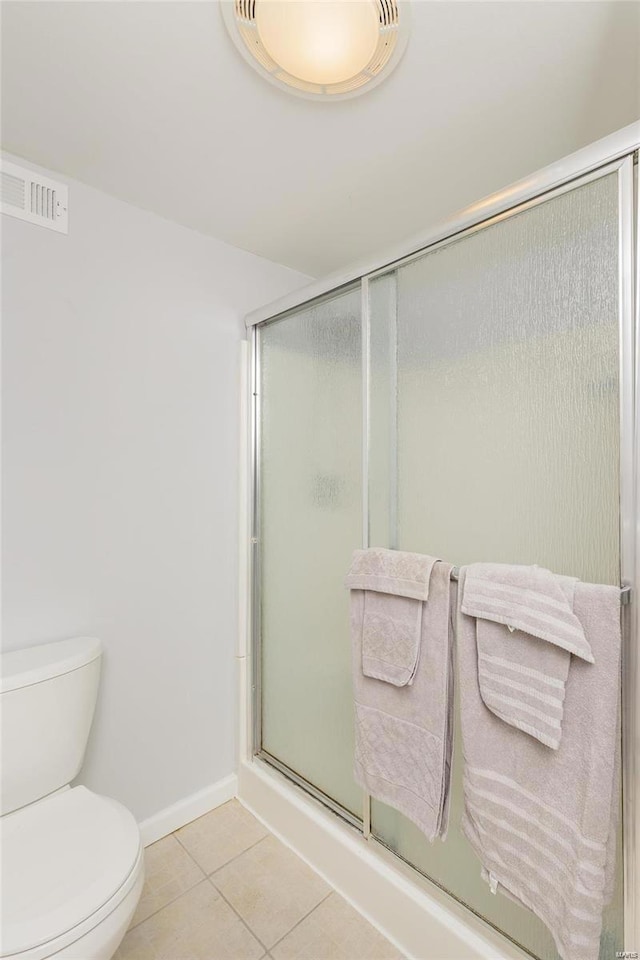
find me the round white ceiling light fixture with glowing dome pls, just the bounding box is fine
[221,0,408,100]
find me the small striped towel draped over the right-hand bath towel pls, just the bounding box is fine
[462,563,593,750]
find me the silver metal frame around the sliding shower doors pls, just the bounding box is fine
[245,122,640,951]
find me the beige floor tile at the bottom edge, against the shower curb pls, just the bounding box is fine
[271,893,401,960]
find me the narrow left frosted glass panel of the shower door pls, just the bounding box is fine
[260,288,362,816]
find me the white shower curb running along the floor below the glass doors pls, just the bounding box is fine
[238,760,530,960]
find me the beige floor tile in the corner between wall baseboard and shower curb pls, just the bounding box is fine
[176,800,268,873]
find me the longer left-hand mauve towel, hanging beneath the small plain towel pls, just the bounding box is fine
[348,551,453,840]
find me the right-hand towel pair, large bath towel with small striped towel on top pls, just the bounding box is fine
[457,564,621,960]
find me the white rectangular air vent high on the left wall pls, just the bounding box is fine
[0,160,69,233]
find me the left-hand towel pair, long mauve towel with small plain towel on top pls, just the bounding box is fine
[345,549,453,840]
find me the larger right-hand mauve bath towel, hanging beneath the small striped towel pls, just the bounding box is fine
[457,570,621,960]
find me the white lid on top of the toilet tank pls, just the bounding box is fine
[0,637,102,693]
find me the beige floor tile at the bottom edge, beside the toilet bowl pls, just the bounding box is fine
[113,880,265,960]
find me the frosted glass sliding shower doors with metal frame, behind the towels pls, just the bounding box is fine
[249,129,638,960]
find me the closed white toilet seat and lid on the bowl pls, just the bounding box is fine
[0,787,143,960]
